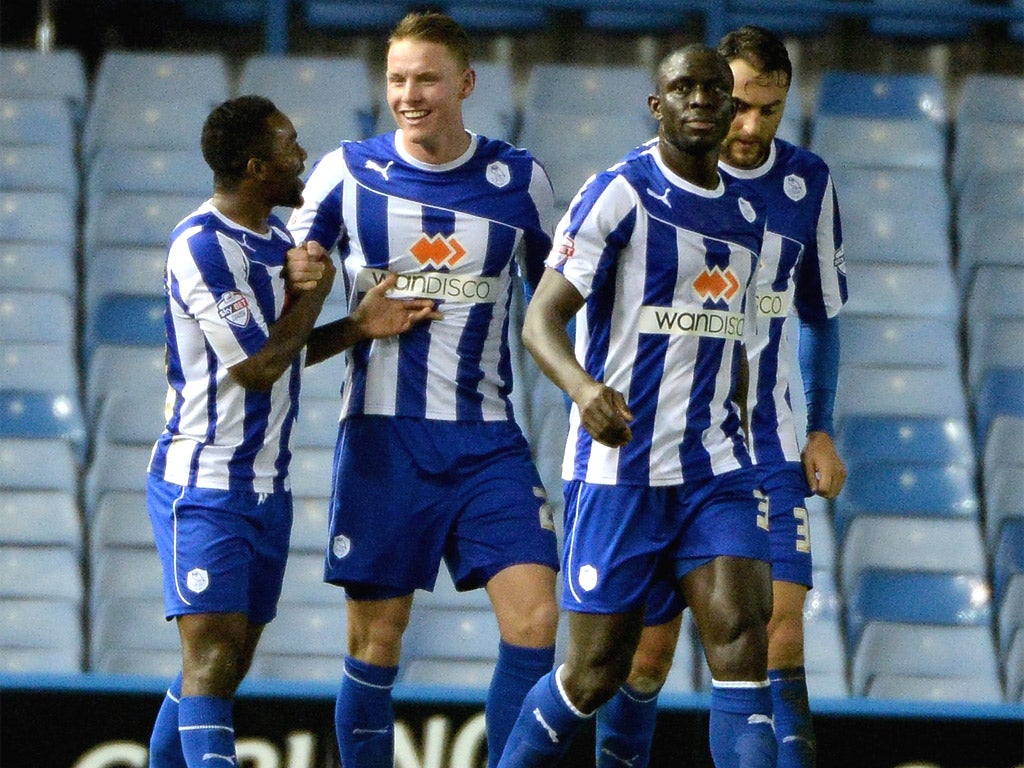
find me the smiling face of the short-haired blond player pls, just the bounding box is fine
[387,39,474,163]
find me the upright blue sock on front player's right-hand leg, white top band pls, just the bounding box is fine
[709,680,776,768]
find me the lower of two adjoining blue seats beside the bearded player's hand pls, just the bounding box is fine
[833,462,980,547]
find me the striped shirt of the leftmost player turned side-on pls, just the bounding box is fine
[150,202,303,493]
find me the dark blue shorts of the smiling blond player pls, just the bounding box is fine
[325,416,558,600]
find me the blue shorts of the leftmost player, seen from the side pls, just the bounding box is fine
[146,475,292,624]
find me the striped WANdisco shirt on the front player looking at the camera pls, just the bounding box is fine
[548,142,765,485]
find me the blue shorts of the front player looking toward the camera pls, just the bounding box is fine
[562,468,769,624]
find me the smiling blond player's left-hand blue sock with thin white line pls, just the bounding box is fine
[334,656,398,768]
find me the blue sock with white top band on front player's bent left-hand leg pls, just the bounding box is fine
[498,667,590,768]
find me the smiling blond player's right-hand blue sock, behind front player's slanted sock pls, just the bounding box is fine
[485,640,555,768]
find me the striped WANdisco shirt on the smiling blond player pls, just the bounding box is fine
[289,132,553,422]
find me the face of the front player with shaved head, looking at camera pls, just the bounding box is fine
[650,50,733,153]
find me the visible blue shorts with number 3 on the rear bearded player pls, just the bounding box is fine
[759,462,813,589]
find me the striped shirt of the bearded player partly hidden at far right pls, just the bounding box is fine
[719,139,847,464]
